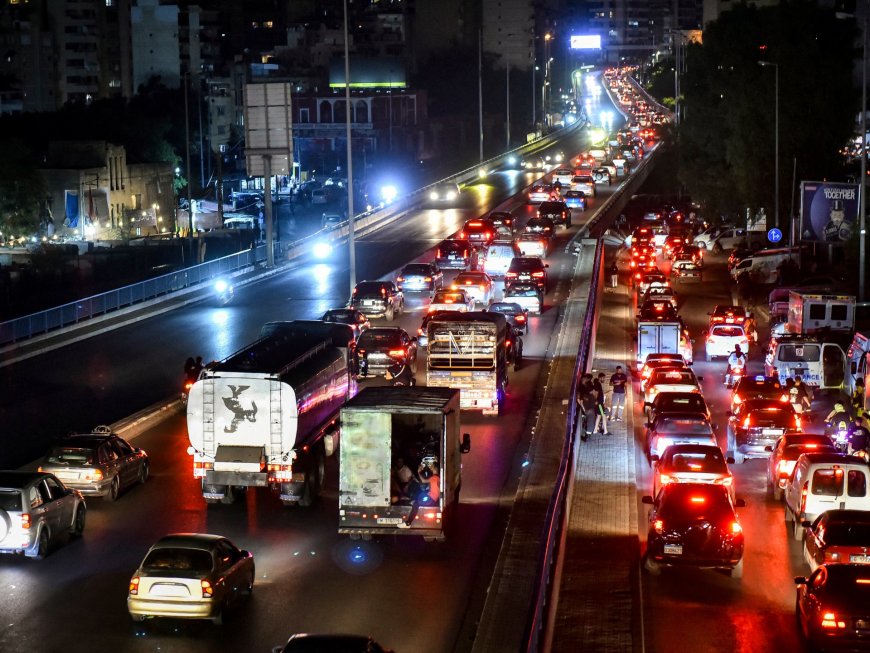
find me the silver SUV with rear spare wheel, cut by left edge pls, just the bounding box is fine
[0,471,87,560]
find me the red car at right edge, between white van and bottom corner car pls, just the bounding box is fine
[804,509,870,569]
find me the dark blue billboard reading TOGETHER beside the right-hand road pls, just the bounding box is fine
[800,181,858,243]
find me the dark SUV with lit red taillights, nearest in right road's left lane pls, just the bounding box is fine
[643,483,743,578]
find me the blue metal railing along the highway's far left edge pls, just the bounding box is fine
[0,245,280,345]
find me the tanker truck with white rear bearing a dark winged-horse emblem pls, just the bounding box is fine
[187,332,356,505]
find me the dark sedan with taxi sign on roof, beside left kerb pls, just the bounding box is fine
[39,426,150,501]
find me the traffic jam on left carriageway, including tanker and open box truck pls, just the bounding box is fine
[0,76,643,650]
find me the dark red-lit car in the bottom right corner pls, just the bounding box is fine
[794,563,870,651]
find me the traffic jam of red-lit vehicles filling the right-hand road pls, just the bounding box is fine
[618,201,870,647]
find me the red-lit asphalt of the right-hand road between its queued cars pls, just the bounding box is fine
[600,207,831,653]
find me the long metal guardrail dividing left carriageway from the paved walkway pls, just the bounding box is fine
[524,135,657,653]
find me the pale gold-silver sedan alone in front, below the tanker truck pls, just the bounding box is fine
[127,533,254,625]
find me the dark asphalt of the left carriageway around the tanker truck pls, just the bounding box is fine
[0,114,632,653]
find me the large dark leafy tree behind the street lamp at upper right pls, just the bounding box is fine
[679,0,857,224]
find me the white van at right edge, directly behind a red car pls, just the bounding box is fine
[784,453,870,540]
